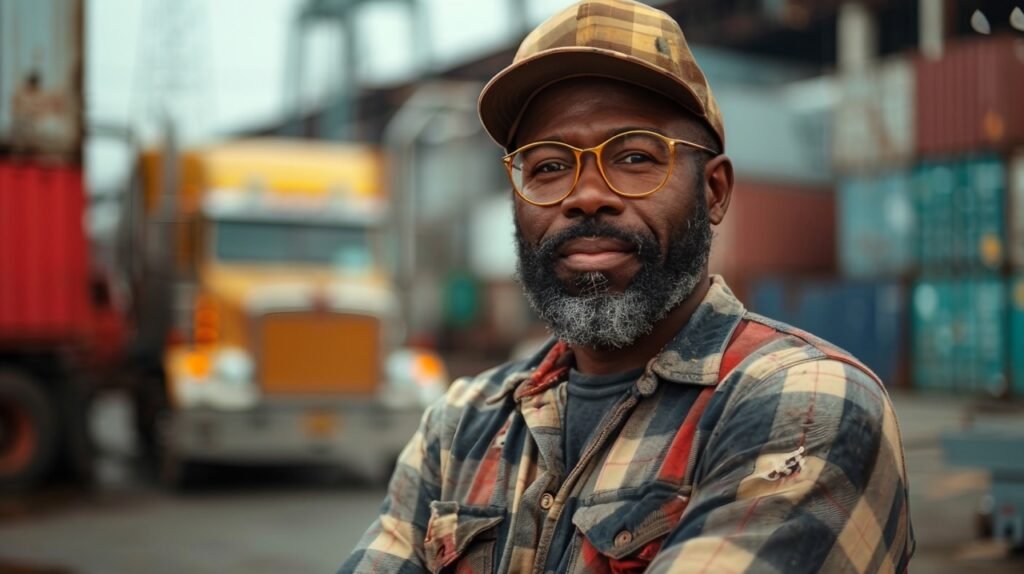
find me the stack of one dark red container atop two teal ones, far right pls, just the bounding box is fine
[911,38,1024,396]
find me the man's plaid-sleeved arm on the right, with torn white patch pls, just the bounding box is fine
[649,360,912,573]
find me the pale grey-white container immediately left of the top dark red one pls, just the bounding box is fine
[833,57,916,172]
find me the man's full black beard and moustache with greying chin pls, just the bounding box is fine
[516,202,712,349]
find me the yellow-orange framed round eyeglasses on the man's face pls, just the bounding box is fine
[502,130,718,207]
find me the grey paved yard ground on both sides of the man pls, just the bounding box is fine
[0,386,1024,574]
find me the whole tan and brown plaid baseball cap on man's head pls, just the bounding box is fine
[478,0,725,148]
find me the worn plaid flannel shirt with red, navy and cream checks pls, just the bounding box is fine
[341,276,913,573]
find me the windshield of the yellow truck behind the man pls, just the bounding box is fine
[213,221,371,269]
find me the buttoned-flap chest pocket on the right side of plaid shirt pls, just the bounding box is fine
[570,482,687,573]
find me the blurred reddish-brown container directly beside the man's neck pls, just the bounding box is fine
[710,181,836,299]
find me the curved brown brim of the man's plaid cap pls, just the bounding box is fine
[478,46,707,148]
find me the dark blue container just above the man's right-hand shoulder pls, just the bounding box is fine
[751,280,907,386]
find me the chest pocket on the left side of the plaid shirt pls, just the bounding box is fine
[423,500,505,574]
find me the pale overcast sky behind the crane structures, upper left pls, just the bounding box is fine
[86,0,585,139]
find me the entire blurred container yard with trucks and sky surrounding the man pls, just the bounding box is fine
[0,0,1024,573]
